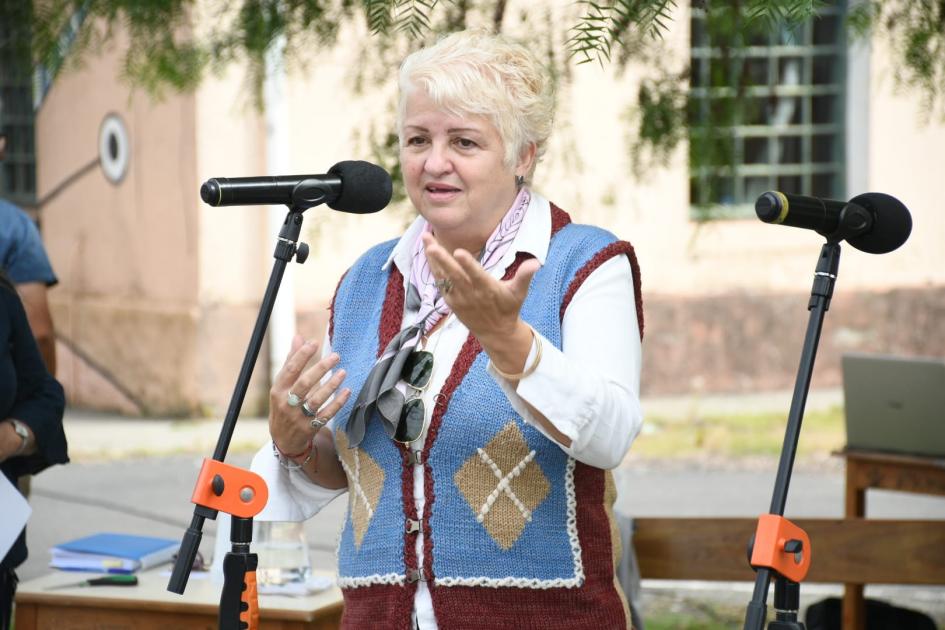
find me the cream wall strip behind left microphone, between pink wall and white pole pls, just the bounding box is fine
[193,60,273,415]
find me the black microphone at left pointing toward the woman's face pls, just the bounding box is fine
[200,160,393,214]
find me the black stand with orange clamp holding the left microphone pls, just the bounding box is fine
[167,204,312,630]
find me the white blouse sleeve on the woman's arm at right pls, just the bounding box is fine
[489,256,643,468]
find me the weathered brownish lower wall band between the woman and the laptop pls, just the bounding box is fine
[642,286,945,396]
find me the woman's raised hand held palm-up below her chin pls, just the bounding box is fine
[422,233,541,348]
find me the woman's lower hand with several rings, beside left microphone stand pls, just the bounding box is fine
[269,335,351,454]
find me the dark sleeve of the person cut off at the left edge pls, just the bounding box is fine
[0,289,69,477]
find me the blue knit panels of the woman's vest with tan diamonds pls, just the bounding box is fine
[332,224,617,589]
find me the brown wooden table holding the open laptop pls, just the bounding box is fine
[837,449,945,630]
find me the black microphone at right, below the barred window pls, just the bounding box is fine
[755,190,912,254]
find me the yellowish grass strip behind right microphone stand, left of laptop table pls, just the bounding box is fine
[633,406,846,458]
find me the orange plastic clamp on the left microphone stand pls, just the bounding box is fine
[190,458,269,518]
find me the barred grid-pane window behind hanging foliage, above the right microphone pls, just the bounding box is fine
[689,0,848,221]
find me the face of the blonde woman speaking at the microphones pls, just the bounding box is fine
[400,89,525,255]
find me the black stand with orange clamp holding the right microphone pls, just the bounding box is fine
[744,238,844,630]
